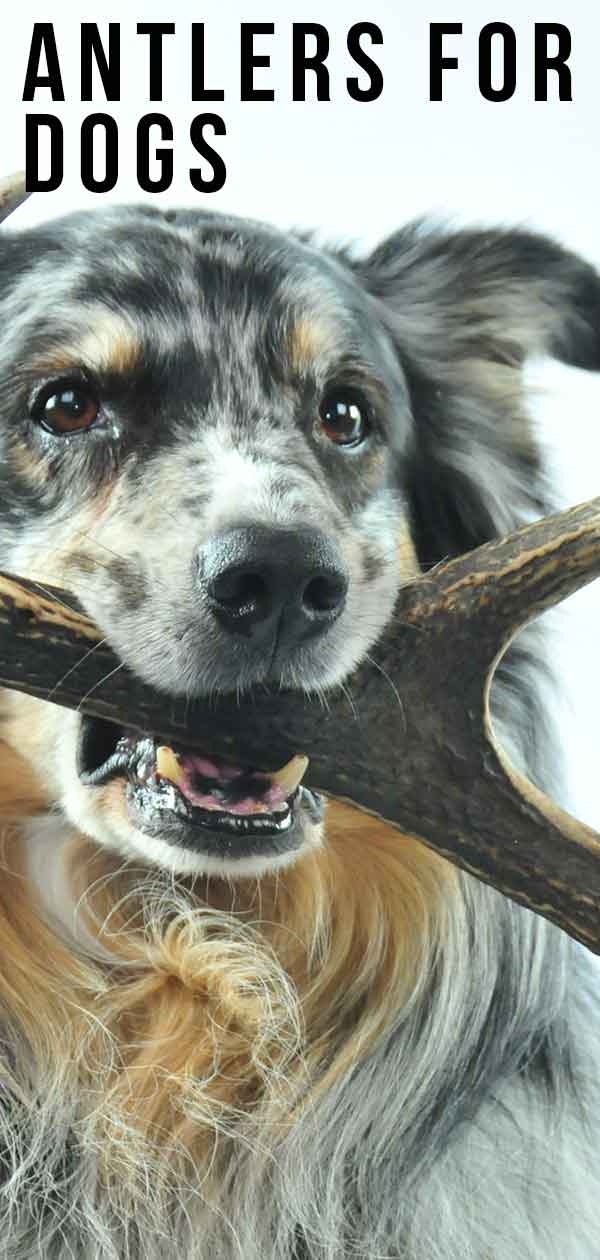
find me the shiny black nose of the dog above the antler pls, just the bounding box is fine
[198,525,348,649]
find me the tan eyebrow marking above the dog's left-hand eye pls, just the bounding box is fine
[33,306,144,375]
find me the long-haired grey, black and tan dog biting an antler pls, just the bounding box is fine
[0,196,600,1260]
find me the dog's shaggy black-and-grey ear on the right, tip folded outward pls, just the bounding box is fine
[345,223,600,564]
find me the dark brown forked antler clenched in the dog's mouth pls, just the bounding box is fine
[0,499,600,953]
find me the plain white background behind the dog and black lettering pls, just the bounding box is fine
[0,0,600,827]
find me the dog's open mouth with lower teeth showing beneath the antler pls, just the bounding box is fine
[77,717,321,840]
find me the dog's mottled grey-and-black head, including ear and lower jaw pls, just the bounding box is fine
[0,201,600,874]
